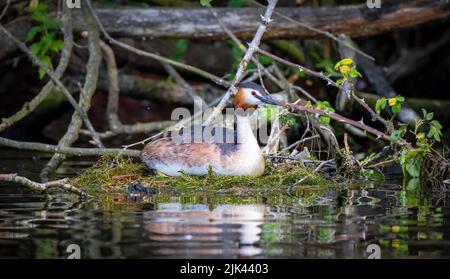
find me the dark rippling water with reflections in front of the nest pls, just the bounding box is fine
[0,150,450,258]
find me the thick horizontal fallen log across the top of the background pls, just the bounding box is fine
[67,0,450,40]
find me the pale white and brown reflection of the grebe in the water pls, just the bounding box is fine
[144,203,267,257]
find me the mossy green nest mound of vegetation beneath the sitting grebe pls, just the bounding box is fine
[70,155,332,199]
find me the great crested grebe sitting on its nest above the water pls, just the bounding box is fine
[141,82,277,176]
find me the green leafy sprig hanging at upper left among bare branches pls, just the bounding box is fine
[26,3,64,79]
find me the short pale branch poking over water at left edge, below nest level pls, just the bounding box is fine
[0,173,86,196]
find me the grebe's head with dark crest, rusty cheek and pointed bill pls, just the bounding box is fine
[233,82,278,110]
